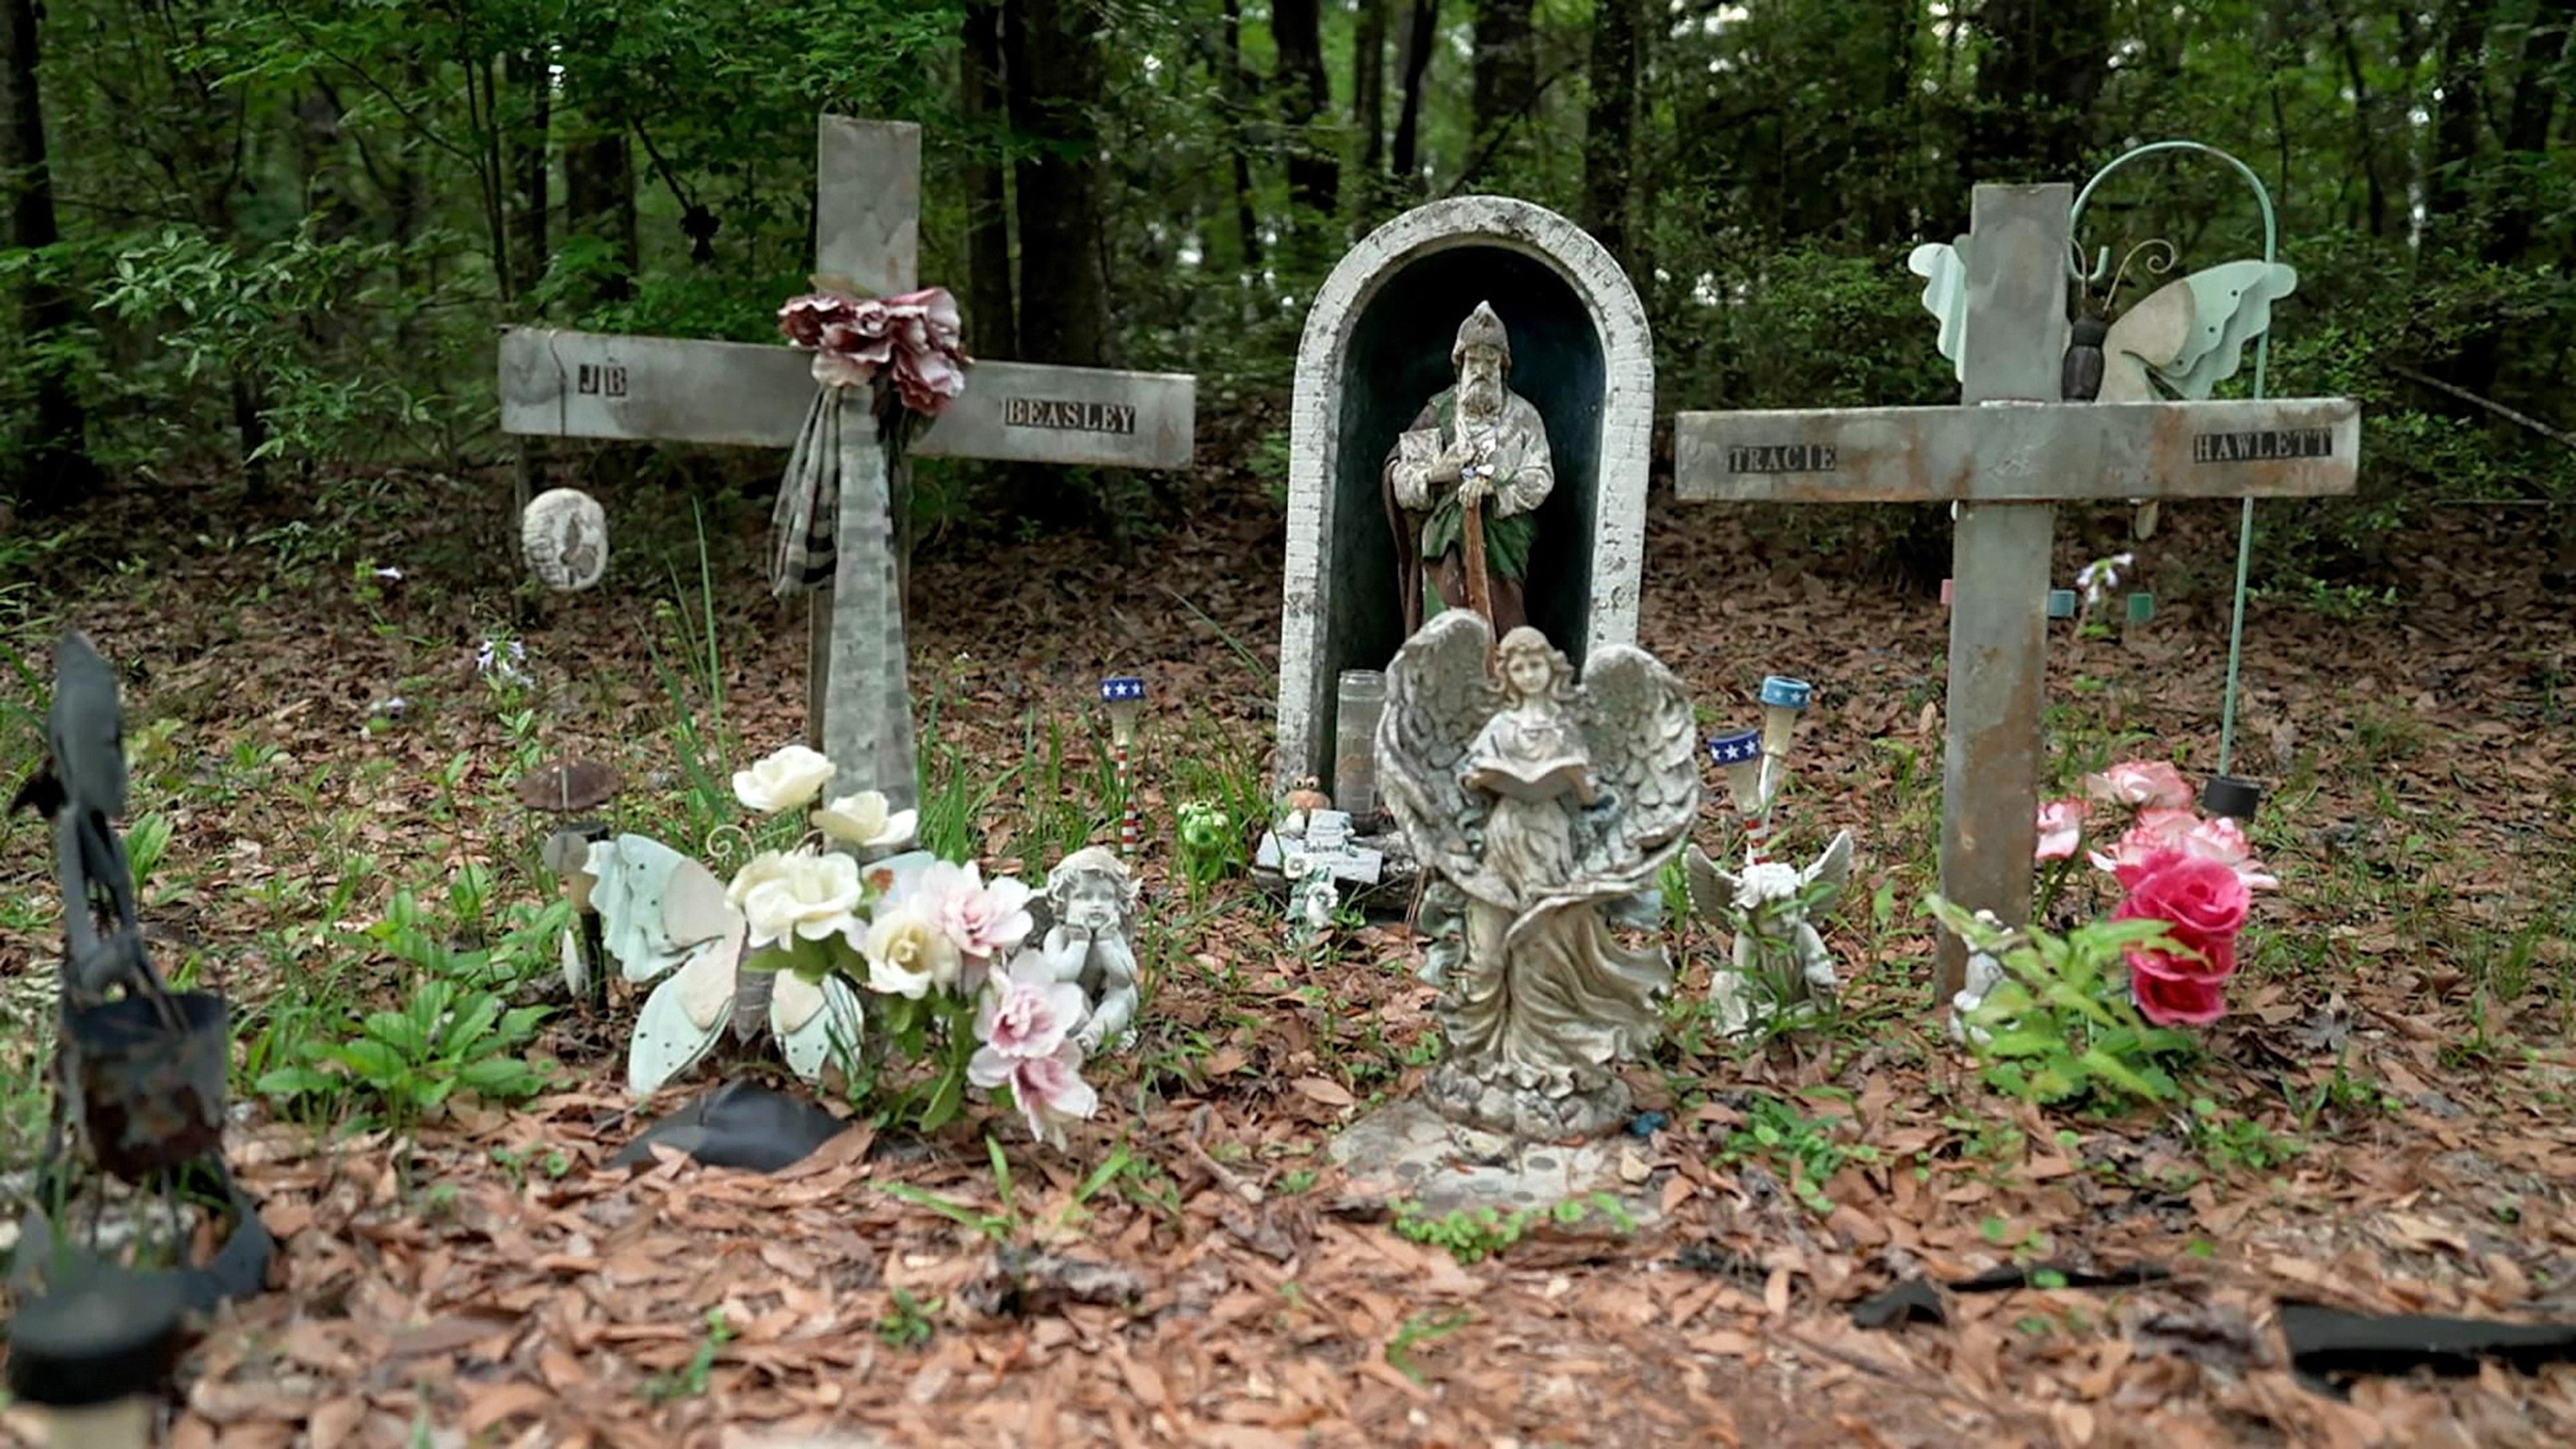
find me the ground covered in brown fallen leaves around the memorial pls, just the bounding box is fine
[0,445,2576,1449]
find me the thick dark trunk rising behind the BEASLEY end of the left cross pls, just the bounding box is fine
[1002,0,1110,366]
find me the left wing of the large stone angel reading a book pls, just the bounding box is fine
[1379,609,1512,900]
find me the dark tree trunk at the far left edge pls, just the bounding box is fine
[0,0,98,513]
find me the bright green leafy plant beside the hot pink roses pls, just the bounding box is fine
[1927,897,2194,1111]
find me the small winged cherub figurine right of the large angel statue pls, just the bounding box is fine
[1687,830,1852,1036]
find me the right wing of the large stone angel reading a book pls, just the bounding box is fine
[1574,645,1701,890]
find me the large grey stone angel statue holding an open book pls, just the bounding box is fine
[1379,611,1701,1140]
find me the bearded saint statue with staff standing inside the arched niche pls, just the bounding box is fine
[1386,302,1555,636]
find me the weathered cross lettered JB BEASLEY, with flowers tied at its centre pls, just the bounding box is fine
[500,116,1197,807]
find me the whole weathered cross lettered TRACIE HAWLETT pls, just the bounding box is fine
[1672,185,2362,1000]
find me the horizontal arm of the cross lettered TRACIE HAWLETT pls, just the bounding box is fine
[1672,397,2362,503]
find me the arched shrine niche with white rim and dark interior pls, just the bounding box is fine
[1275,196,1654,792]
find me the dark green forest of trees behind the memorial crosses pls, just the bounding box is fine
[0,0,2576,598]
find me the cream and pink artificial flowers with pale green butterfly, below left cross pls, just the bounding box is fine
[607,745,1100,1145]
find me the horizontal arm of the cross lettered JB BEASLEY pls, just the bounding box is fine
[500,327,1197,470]
